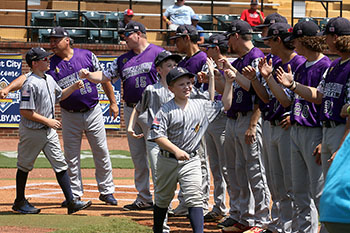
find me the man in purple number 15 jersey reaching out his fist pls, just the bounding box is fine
[81,21,164,210]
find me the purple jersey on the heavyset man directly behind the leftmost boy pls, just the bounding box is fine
[47,48,101,112]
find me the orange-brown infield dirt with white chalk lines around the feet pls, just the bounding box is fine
[0,169,224,233]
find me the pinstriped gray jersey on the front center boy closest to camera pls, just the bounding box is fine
[148,99,223,153]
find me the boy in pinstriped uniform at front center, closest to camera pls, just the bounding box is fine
[148,67,222,232]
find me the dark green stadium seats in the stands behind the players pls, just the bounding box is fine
[31,11,329,47]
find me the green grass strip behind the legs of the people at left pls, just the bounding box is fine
[0,150,134,169]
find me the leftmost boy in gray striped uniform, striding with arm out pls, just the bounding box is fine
[12,48,91,214]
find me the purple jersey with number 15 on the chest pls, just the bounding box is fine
[103,44,164,103]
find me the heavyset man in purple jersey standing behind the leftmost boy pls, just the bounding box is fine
[0,27,119,206]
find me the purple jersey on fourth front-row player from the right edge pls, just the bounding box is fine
[227,47,265,117]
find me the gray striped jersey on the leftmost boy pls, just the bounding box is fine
[20,73,62,129]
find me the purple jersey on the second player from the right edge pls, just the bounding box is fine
[290,56,331,127]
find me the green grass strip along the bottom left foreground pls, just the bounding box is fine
[0,212,152,233]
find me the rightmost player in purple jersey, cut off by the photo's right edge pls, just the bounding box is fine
[280,17,350,176]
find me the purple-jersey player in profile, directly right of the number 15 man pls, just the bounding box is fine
[169,25,210,215]
